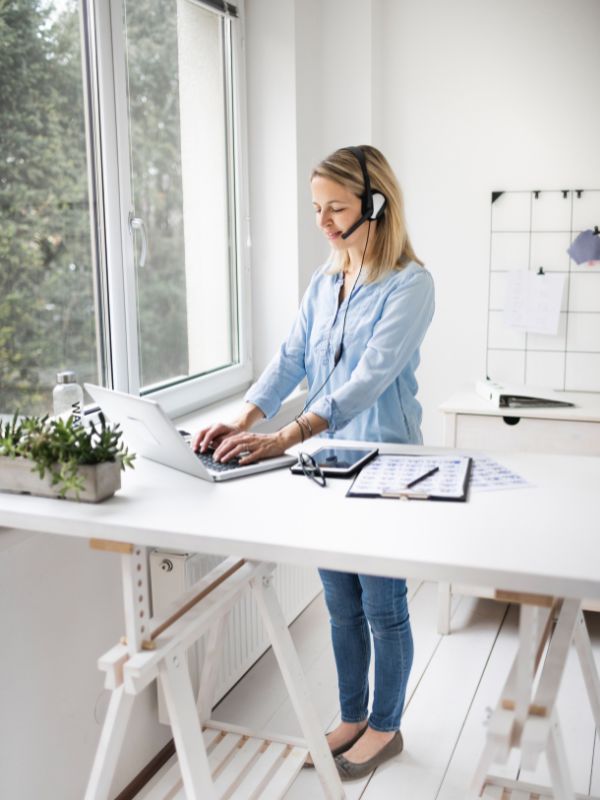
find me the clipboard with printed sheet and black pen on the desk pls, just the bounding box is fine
[346,454,472,503]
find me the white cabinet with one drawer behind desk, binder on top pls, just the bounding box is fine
[438,391,600,633]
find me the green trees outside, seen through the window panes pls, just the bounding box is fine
[0,0,188,415]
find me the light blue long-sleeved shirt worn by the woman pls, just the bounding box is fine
[245,262,434,444]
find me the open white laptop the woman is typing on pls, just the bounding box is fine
[85,383,296,481]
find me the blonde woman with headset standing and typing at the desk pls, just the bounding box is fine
[194,146,434,779]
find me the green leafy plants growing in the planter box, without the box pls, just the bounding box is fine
[0,414,135,497]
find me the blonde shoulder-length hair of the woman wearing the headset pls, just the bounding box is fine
[310,145,423,283]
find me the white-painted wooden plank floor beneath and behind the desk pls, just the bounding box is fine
[142,583,600,800]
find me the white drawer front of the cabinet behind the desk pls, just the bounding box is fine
[455,414,600,456]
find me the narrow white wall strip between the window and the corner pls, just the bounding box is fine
[245,0,298,373]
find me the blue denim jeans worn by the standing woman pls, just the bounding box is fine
[319,570,413,731]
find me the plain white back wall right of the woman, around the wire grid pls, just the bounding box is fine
[379,0,600,443]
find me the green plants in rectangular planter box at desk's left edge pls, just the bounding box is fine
[0,414,135,503]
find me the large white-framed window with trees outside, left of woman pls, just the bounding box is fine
[0,0,251,413]
